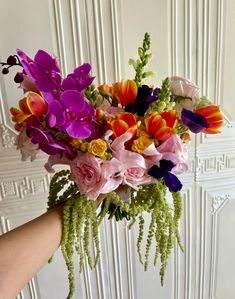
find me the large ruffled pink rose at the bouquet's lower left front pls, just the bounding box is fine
[70,153,121,200]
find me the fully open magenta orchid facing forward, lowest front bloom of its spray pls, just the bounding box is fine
[47,90,95,139]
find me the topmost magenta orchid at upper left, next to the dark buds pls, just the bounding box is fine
[17,49,61,103]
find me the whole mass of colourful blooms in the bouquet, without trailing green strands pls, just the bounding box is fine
[7,50,223,200]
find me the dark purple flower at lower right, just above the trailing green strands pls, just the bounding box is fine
[148,159,182,192]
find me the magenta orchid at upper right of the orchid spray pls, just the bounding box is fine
[61,63,95,91]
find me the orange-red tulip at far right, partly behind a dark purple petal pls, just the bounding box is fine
[194,105,223,134]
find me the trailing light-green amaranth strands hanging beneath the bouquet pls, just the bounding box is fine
[48,170,183,299]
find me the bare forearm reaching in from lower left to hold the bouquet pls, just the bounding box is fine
[0,206,63,299]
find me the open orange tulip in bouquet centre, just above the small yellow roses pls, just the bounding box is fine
[107,112,139,138]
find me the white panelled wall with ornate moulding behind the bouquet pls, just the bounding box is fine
[0,0,235,299]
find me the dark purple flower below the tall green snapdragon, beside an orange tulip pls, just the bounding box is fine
[125,85,159,116]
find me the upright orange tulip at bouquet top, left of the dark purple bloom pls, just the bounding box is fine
[113,80,138,106]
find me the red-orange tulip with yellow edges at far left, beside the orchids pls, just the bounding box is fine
[10,91,47,130]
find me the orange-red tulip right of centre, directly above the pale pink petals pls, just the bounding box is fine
[144,110,178,141]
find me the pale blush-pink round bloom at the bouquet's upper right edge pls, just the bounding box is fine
[170,76,200,98]
